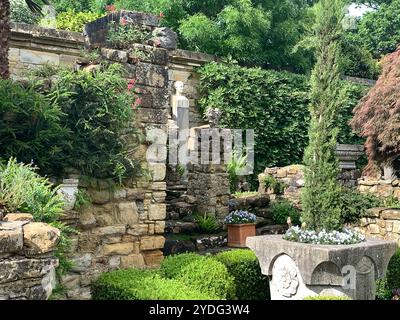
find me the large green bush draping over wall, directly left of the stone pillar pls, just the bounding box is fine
[37,64,140,183]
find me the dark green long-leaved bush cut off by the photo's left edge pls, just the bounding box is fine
[0,80,69,173]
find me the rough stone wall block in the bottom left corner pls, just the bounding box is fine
[0,214,60,300]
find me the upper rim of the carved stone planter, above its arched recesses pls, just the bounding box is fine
[247,235,397,285]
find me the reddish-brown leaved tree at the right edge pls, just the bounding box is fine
[350,48,400,177]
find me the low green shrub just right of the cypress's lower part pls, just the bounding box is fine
[340,188,382,223]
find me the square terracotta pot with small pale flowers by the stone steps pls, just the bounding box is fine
[225,210,257,248]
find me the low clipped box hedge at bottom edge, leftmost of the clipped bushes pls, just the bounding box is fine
[91,269,213,300]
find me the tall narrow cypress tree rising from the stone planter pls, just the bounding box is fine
[302,0,345,230]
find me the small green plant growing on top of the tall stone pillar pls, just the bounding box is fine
[107,22,149,49]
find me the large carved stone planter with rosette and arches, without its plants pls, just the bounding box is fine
[247,235,397,300]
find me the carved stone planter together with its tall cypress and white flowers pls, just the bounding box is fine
[247,0,397,300]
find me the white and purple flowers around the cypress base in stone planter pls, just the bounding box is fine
[283,226,365,245]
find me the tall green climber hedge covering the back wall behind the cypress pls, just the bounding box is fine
[199,62,365,179]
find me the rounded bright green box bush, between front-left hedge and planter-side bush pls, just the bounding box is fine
[176,258,236,299]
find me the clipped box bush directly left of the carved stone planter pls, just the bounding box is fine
[215,249,269,300]
